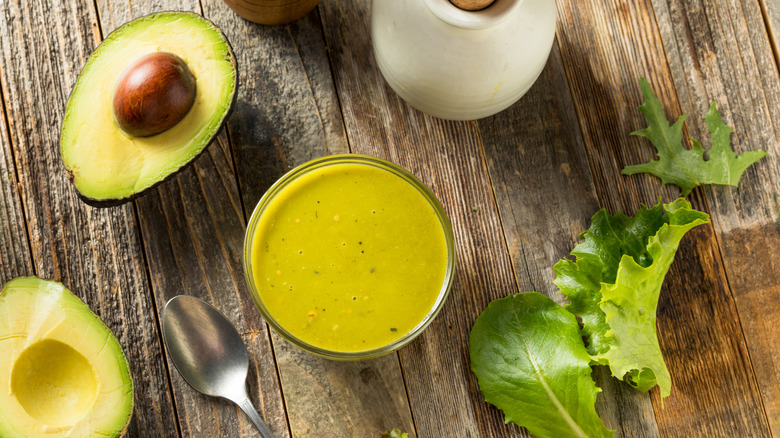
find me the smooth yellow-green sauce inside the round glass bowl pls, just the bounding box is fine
[251,163,448,352]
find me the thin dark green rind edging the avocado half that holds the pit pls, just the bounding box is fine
[58,11,239,208]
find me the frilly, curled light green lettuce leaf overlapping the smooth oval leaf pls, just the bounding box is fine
[554,198,708,397]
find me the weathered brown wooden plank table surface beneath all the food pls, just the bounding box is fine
[0,0,780,437]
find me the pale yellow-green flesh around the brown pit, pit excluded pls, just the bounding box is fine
[60,12,236,205]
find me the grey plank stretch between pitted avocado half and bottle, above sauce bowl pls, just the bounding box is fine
[203,0,349,210]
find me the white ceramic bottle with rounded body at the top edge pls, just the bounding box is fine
[371,0,555,120]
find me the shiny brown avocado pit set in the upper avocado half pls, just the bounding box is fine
[113,52,196,137]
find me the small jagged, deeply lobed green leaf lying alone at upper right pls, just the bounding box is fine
[621,78,767,196]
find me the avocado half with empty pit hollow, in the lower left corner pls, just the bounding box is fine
[0,277,133,438]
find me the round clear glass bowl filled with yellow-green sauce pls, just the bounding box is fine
[244,154,455,360]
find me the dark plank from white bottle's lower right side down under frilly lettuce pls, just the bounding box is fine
[477,45,659,437]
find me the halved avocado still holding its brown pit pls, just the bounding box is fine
[60,12,236,206]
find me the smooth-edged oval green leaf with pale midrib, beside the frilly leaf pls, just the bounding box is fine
[469,292,613,438]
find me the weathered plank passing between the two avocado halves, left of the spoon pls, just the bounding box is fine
[0,1,177,437]
